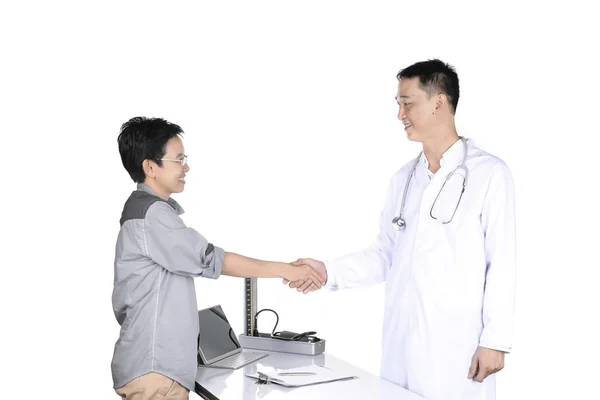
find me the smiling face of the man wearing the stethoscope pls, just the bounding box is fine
[396,77,436,142]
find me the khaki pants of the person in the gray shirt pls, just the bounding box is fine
[116,372,189,400]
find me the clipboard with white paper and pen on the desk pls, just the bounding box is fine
[246,365,358,388]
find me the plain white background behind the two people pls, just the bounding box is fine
[0,1,600,400]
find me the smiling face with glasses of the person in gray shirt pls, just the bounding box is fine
[144,136,190,199]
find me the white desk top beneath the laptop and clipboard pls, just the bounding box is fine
[196,352,424,400]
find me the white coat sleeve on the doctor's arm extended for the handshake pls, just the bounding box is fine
[324,180,395,291]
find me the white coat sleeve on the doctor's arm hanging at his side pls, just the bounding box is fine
[479,163,516,352]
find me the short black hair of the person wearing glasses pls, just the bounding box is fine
[117,117,183,183]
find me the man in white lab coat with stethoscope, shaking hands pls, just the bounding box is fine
[284,60,515,400]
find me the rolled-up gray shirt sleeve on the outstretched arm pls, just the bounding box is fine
[143,201,225,279]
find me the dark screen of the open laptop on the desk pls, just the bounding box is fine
[198,306,241,364]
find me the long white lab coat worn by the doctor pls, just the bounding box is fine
[325,140,515,400]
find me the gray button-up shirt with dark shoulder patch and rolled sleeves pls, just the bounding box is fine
[111,184,225,391]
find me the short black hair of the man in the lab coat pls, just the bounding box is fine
[396,59,460,114]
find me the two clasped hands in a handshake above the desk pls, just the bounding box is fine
[283,258,327,294]
